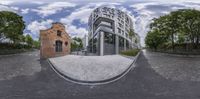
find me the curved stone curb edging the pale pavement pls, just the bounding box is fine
[47,51,141,85]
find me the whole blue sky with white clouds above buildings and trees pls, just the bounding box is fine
[0,0,200,46]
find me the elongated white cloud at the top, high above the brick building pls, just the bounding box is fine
[32,2,76,17]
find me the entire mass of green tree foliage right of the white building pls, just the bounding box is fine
[145,9,200,50]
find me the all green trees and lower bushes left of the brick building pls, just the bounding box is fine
[0,11,40,54]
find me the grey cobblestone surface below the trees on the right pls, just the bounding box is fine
[144,51,200,81]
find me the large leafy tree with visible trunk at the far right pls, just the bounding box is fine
[150,9,200,51]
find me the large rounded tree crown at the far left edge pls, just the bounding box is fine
[0,11,25,44]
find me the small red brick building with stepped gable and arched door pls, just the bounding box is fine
[40,22,71,58]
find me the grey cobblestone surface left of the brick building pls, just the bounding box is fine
[0,51,41,80]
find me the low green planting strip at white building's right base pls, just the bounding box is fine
[120,49,140,56]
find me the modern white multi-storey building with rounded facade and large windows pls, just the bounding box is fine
[88,6,140,55]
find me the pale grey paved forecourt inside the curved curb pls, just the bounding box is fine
[49,55,134,82]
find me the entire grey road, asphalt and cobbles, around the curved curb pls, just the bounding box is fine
[0,51,200,99]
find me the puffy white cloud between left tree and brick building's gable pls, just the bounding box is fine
[27,19,53,35]
